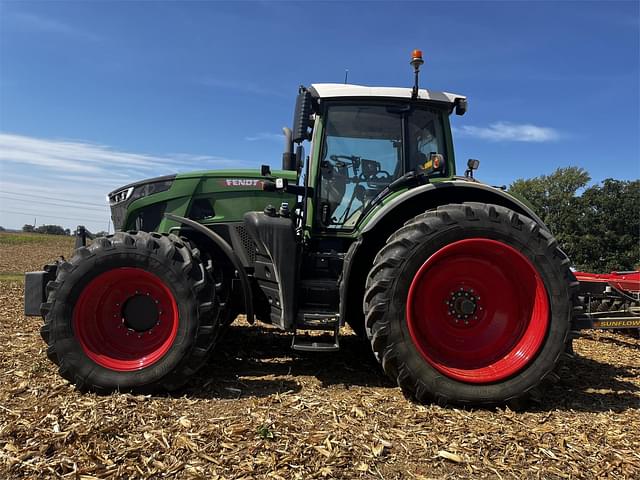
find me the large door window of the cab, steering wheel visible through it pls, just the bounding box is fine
[317,105,403,229]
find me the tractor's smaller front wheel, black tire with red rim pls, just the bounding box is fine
[41,232,219,393]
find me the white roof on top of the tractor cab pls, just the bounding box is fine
[310,83,466,103]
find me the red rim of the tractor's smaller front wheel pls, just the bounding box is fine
[73,267,179,372]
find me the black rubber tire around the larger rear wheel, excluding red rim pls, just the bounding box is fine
[370,205,570,403]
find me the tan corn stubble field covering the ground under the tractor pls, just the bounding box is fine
[0,234,640,479]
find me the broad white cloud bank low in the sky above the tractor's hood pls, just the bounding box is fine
[0,133,251,231]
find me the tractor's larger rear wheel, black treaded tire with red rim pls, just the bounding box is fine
[364,203,577,405]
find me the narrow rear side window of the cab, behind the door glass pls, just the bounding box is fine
[407,109,446,174]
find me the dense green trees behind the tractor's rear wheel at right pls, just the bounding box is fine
[509,167,640,273]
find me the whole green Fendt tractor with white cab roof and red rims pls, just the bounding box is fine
[25,50,578,405]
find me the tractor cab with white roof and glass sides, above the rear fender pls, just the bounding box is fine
[294,84,466,232]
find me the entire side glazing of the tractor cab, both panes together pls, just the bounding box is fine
[317,104,445,229]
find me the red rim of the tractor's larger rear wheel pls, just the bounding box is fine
[406,238,549,383]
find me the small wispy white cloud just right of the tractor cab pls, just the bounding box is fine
[454,122,561,143]
